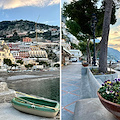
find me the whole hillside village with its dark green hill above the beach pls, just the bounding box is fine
[0,20,60,71]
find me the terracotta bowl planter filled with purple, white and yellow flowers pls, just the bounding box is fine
[97,79,120,120]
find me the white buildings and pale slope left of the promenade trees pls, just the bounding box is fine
[61,16,82,66]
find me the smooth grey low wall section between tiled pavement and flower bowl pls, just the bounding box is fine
[80,67,101,99]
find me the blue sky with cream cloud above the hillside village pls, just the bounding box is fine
[0,0,60,26]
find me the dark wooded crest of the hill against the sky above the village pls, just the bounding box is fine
[0,20,59,36]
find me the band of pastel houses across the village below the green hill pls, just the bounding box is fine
[0,37,59,71]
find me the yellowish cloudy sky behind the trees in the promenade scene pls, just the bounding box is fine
[61,0,120,51]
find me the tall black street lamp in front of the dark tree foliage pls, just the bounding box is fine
[92,13,97,66]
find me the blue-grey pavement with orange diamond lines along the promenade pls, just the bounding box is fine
[61,62,82,120]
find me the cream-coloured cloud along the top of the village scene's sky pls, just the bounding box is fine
[0,0,60,9]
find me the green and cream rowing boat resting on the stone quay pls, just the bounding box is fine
[12,97,60,117]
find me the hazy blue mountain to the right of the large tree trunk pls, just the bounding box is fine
[108,47,120,61]
